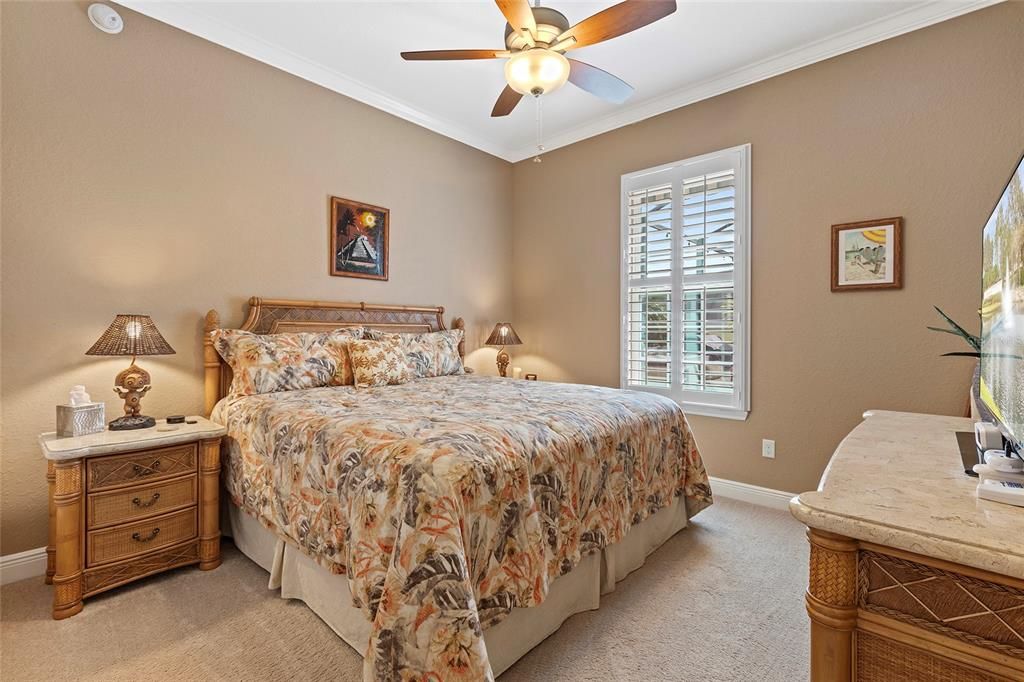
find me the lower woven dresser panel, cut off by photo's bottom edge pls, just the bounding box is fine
[856,632,1009,682]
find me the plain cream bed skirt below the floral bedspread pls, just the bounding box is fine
[222,498,686,676]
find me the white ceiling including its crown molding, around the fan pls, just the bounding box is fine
[120,0,994,161]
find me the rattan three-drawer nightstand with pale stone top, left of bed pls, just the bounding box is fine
[39,417,225,619]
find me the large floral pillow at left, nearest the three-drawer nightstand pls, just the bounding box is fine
[210,328,362,395]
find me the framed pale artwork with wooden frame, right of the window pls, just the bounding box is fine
[831,218,903,291]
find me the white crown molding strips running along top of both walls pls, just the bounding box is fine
[117,0,1004,163]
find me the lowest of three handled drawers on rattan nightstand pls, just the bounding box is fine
[86,507,198,566]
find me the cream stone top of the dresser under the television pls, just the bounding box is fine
[790,411,1024,579]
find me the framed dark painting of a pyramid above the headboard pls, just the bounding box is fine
[330,197,388,280]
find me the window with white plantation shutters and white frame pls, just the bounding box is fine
[622,144,751,419]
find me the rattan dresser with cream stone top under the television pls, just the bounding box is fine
[790,411,1024,682]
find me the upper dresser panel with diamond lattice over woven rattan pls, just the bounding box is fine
[858,551,1024,660]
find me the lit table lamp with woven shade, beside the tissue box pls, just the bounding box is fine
[85,314,174,431]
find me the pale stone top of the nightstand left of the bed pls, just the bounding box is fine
[39,417,227,461]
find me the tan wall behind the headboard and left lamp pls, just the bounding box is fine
[0,3,512,554]
